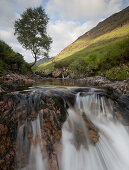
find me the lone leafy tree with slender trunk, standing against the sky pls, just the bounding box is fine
[14,7,52,66]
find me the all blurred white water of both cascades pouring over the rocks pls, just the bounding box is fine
[17,85,129,170]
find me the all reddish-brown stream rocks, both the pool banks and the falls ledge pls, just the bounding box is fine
[0,74,129,170]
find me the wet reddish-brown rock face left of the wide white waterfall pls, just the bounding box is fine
[0,94,66,170]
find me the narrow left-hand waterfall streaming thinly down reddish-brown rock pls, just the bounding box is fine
[17,116,47,170]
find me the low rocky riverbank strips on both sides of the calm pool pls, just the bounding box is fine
[0,73,129,96]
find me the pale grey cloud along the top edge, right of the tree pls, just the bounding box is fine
[47,0,123,19]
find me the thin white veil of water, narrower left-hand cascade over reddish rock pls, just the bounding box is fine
[18,116,47,170]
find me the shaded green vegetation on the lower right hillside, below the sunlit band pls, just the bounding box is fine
[50,37,129,80]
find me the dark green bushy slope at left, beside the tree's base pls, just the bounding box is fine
[0,41,30,74]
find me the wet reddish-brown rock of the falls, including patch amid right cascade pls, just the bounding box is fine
[0,88,128,170]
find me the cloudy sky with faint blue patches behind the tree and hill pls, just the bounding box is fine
[0,0,129,62]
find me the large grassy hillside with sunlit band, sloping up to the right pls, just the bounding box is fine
[36,7,129,80]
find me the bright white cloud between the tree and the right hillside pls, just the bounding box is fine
[48,21,97,56]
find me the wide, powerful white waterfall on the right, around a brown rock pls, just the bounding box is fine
[62,93,129,170]
